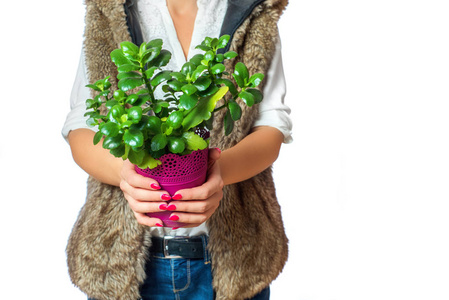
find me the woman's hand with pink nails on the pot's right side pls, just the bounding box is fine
[166,149,224,227]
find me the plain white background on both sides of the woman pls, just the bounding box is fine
[0,0,449,300]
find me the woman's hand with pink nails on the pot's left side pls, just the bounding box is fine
[120,160,171,227]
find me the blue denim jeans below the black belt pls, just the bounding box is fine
[89,238,270,300]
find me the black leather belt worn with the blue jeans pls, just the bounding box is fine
[150,236,206,258]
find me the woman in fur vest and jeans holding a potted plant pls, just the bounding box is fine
[63,0,291,299]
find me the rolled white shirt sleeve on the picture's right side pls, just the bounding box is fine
[254,42,293,144]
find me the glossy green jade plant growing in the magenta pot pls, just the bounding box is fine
[85,35,264,168]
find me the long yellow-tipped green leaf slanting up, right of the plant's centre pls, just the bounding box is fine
[182,86,229,130]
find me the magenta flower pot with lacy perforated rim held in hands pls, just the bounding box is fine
[135,148,209,227]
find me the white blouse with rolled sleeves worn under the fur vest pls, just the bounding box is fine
[62,0,292,236]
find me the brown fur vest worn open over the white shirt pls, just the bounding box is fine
[67,0,288,300]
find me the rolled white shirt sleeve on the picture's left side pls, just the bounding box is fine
[62,50,96,142]
